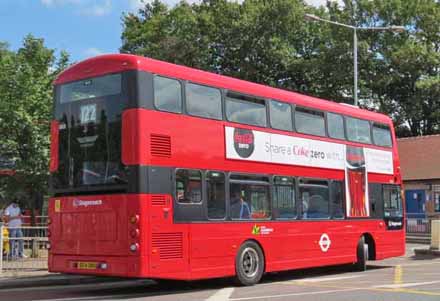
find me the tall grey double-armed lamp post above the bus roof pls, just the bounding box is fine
[304,14,405,106]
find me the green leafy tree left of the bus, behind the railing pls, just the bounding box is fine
[0,35,68,212]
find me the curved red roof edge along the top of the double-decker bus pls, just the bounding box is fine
[55,54,392,125]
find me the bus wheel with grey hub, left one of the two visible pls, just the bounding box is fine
[235,241,264,286]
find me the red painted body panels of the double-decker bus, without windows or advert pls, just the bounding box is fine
[49,55,405,280]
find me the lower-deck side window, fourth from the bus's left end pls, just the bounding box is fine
[272,176,297,219]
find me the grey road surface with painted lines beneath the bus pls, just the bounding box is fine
[0,244,440,301]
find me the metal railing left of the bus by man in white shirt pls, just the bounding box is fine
[0,224,49,273]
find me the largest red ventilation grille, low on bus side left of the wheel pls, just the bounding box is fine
[152,232,183,259]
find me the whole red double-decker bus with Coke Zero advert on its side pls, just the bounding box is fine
[49,54,405,285]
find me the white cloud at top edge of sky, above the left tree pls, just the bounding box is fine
[40,0,112,16]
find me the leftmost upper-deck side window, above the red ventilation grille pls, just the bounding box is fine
[154,76,182,113]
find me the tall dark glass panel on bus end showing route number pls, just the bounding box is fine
[52,73,127,192]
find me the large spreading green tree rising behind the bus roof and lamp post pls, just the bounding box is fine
[121,0,440,136]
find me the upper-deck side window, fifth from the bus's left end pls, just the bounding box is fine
[295,107,325,136]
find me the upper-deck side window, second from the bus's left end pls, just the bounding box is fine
[186,83,222,120]
